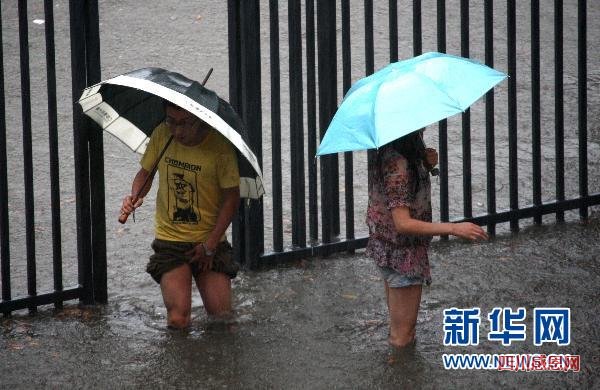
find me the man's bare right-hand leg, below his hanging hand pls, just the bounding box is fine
[196,271,231,317]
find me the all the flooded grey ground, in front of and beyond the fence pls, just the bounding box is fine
[0,0,600,389]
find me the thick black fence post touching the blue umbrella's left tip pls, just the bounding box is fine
[317,0,339,251]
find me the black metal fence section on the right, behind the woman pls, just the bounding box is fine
[228,0,600,267]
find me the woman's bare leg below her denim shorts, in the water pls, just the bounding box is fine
[386,284,422,348]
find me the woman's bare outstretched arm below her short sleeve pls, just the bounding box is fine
[392,206,488,241]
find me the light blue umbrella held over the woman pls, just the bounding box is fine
[317,52,506,155]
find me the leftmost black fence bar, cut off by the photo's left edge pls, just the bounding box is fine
[0,0,12,314]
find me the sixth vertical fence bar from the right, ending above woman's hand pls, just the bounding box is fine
[460,0,473,218]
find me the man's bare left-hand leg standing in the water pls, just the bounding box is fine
[160,264,192,329]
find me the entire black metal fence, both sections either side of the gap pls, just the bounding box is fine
[0,0,600,314]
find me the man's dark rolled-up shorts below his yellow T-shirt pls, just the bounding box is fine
[146,239,240,284]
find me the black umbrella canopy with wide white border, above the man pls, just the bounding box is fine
[79,68,264,199]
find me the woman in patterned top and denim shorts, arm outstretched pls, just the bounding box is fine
[366,132,487,348]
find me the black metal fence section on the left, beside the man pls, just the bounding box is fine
[0,0,107,315]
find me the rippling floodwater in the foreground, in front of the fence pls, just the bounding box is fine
[0,215,600,389]
